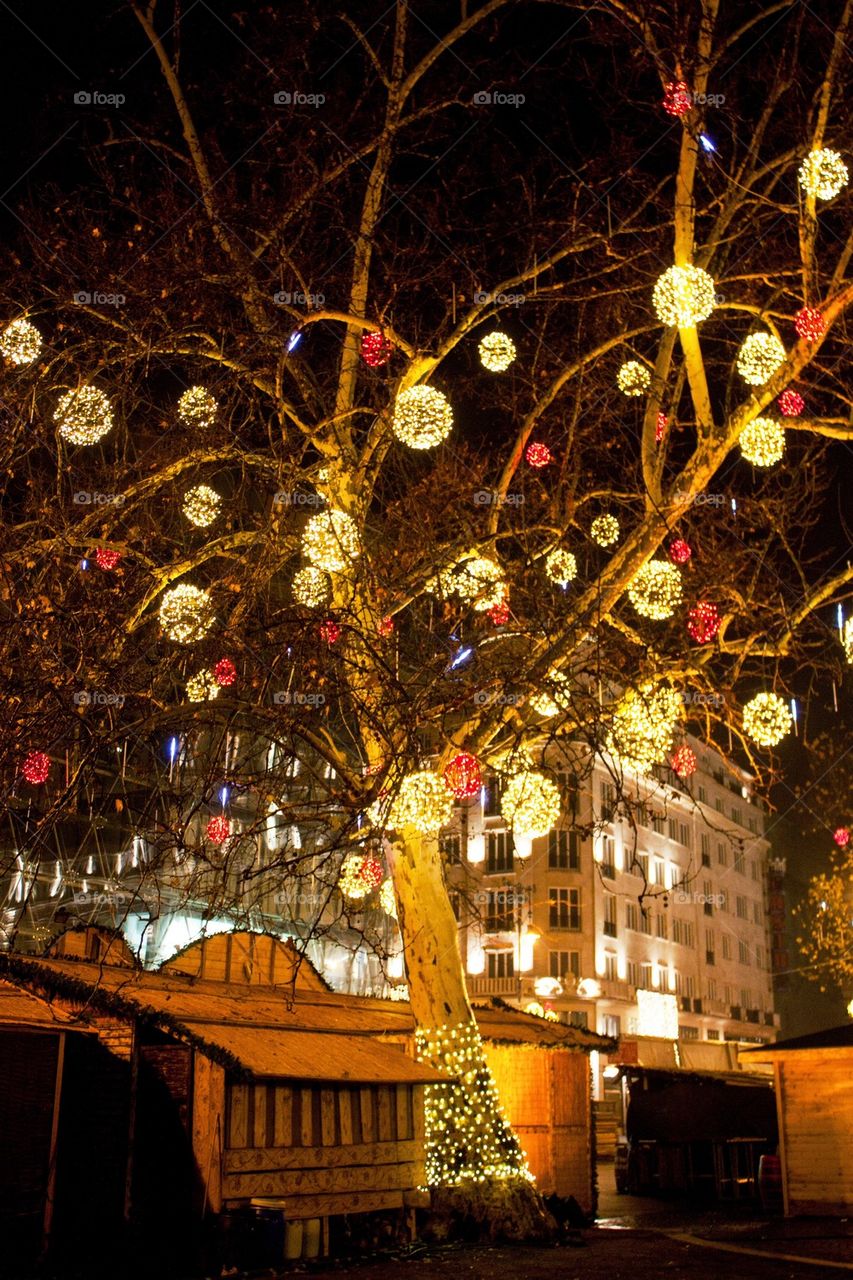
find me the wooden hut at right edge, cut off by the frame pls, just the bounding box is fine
[740,1023,853,1216]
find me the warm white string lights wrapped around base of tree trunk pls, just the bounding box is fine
[415,1021,534,1187]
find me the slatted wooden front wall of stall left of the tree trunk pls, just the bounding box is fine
[216,1082,424,1217]
